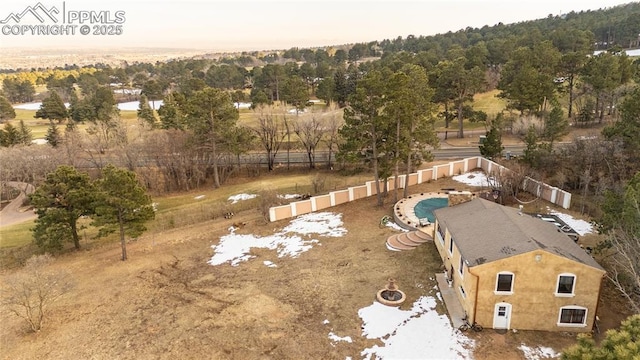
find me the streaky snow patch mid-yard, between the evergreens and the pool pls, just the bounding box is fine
[208,212,347,266]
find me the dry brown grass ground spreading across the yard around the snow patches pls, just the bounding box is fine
[0,165,624,360]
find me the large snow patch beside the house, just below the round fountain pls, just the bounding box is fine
[358,296,475,360]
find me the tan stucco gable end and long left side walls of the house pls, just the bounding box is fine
[433,200,605,332]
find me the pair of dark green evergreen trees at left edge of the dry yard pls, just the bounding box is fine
[29,165,155,260]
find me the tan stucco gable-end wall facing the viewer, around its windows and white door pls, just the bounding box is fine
[465,250,605,332]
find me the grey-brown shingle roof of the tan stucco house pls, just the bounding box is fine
[433,198,603,270]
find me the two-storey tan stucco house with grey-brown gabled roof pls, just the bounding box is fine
[433,198,605,332]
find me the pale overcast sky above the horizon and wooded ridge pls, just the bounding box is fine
[0,0,631,51]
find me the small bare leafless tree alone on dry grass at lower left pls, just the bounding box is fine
[2,254,74,331]
